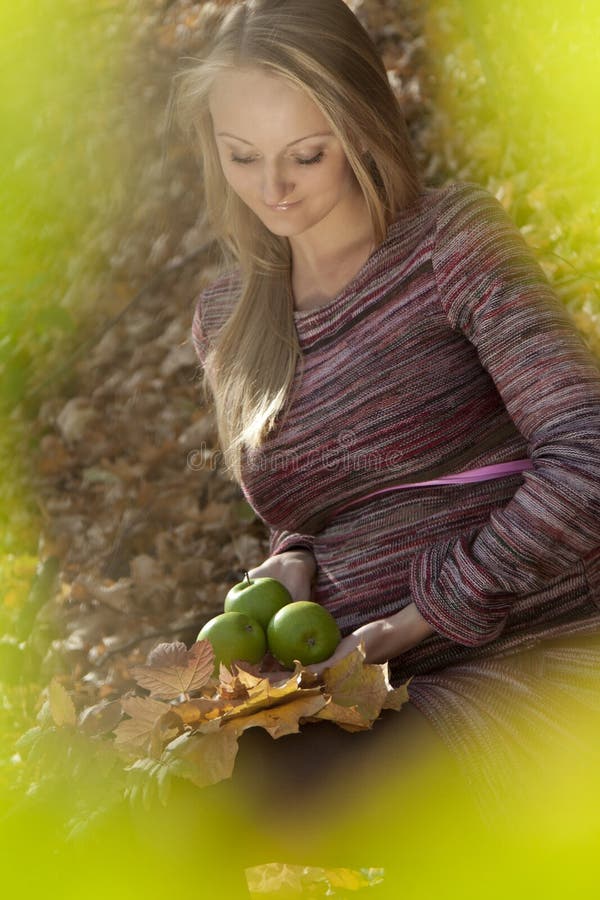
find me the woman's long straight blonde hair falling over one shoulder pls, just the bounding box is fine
[174,0,421,483]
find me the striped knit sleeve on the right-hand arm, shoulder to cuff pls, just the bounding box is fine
[410,184,600,646]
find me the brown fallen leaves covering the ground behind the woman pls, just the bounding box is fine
[8,0,441,764]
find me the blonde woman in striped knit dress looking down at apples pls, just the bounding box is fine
[171,0,600,824]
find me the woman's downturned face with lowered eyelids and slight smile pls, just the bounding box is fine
[209,69,360,236]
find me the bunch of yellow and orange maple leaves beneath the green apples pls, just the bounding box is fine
[48,640,408,795]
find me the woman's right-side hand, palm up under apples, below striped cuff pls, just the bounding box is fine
[306,603,435,675]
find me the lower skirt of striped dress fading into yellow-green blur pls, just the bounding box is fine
[408,633,600,820]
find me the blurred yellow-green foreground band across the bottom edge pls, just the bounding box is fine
[0,704,600,900]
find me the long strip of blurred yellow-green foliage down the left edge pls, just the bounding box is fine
[0,0,136,800]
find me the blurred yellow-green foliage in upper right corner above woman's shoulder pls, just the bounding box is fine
[426,0,600,348]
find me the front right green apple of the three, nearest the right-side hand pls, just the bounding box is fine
[267,600,342,669]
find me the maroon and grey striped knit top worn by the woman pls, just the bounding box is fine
[192,183,600,682]
